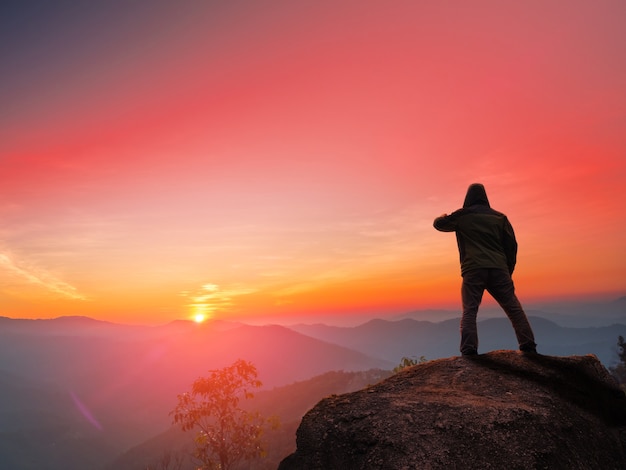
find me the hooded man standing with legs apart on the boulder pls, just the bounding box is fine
[433,183,537,356]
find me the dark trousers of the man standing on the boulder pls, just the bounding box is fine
[461,269,537,354]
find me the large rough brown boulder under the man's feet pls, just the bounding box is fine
[279,351,626,470]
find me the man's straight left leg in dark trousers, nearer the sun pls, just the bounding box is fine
[461,269,487,355]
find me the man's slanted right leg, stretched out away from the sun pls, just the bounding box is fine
[487,269,537,352]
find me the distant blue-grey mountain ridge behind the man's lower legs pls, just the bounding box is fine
[290,314,626,366]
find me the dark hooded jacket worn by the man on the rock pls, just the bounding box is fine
[433,183,517,275]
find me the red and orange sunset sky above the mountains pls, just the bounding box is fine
[0,0,626,324]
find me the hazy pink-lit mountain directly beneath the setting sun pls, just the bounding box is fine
[0,318,392,470]
